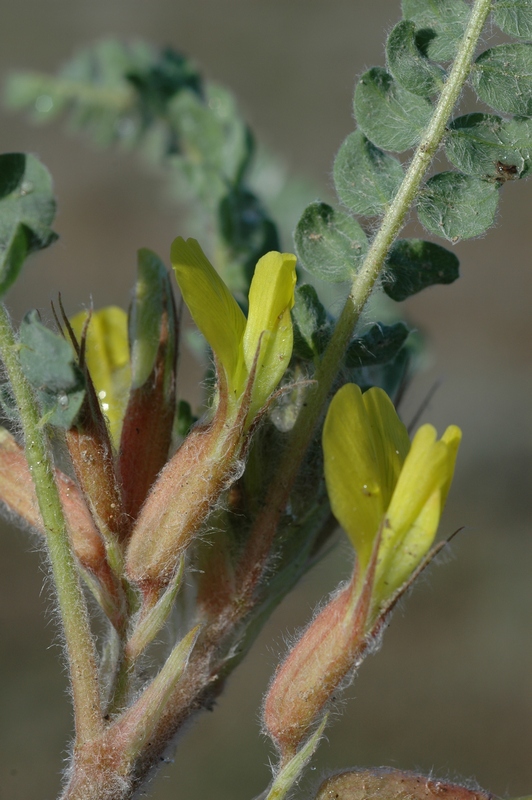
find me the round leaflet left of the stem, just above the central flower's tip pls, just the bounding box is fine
[294,201,368,283]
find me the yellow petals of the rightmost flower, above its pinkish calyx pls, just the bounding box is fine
[323,384,461,607]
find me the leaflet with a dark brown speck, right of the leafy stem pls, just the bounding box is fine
[445,113,532,182]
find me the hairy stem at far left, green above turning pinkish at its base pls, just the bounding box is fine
[0,304,103,746]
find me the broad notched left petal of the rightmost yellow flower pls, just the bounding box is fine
[323,384,409,570]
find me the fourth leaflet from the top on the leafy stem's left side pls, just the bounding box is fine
[333,130,404,217]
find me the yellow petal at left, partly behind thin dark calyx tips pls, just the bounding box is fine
[70,306,131,443]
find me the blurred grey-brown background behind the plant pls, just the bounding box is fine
[0,0,532,800]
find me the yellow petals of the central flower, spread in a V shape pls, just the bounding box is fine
[170,236,296,421]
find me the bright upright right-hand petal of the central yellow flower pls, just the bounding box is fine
[242,252,296,417]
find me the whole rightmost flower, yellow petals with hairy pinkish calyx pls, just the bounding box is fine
[264,384,461,760]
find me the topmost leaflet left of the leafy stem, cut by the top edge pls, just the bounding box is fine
[402,0,470,61]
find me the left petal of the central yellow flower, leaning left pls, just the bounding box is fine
[170,236,246,392]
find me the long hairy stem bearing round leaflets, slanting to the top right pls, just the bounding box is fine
[237,0,491,594]
